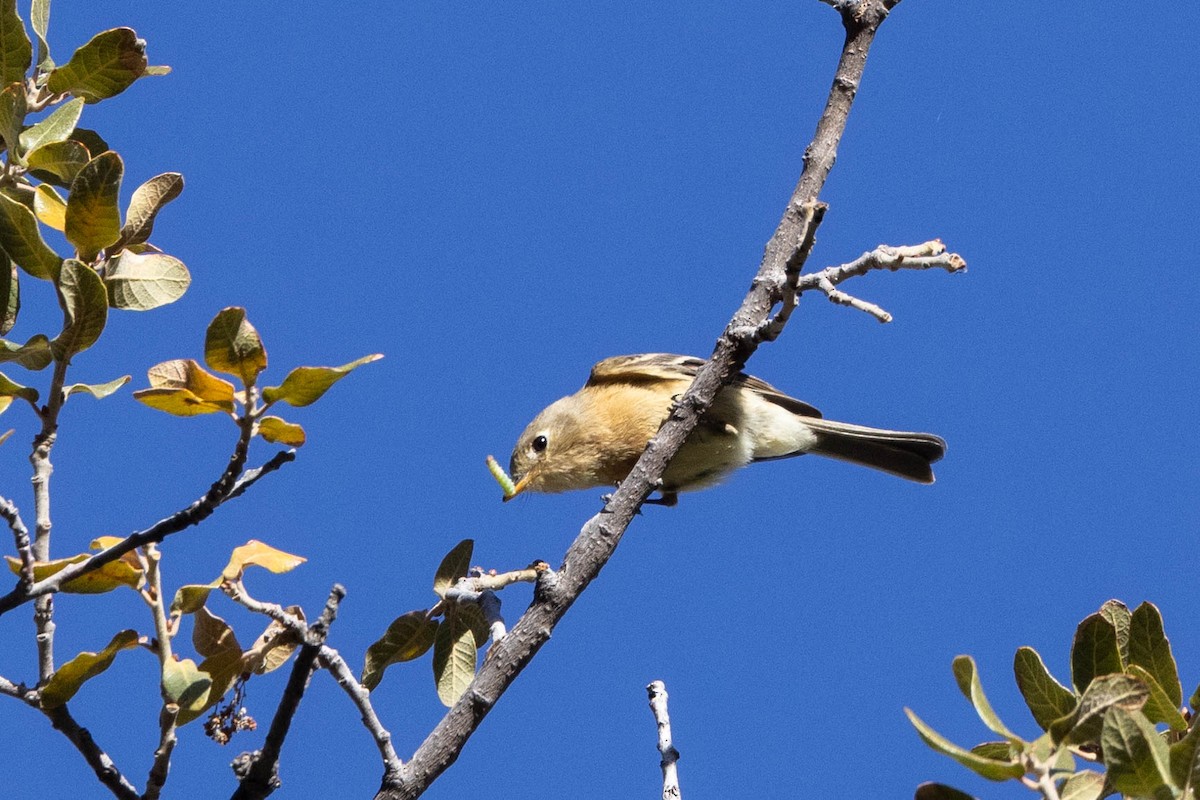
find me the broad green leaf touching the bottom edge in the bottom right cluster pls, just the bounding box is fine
[1100,708,1172,798]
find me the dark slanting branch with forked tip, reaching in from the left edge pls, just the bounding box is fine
[0,420,295,614]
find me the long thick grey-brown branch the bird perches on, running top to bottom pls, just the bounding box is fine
[377,0,921,800]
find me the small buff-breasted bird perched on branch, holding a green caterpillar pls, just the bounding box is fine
[504,353,946,506]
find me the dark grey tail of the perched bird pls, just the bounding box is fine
[763,417,946,483]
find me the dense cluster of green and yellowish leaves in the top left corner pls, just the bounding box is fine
[0,0,177,424]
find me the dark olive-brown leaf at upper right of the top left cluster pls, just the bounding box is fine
[47,28,146,103]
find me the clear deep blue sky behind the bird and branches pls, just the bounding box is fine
[0,0,1200,799]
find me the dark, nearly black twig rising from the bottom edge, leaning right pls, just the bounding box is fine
[233,584,346,800]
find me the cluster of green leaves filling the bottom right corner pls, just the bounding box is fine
[905,600,1200,800]
